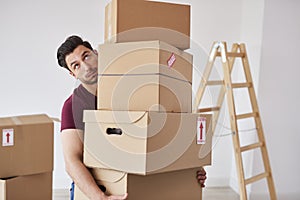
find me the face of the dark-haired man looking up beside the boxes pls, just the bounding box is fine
[66,45,98,85]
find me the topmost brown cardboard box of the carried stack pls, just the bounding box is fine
[104,0,190,50]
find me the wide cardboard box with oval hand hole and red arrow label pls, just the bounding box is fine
[83,110,212,175]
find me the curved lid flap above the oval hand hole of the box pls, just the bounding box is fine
[83,110,148,124]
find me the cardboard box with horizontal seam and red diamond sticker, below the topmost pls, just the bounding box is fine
[97,41,193,112]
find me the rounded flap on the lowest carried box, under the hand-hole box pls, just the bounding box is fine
[90,168,126,183]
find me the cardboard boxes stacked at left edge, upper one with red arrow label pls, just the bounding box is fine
[0,115,54,200]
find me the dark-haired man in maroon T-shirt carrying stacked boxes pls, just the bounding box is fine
[57,36,206,200]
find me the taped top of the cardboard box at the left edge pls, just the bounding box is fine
[0,114,53,126]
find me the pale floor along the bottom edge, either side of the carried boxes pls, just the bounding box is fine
[53,187,239,200]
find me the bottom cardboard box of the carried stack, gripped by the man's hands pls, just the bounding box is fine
[75,168,202,200]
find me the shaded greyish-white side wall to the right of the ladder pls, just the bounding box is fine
[253,0,300,200]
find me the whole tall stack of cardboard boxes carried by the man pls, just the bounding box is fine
[75,0,211,200]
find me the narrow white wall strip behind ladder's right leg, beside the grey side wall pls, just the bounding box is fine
[230,0,264,192]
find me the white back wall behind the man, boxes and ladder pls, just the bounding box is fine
[0,0,292,197]
